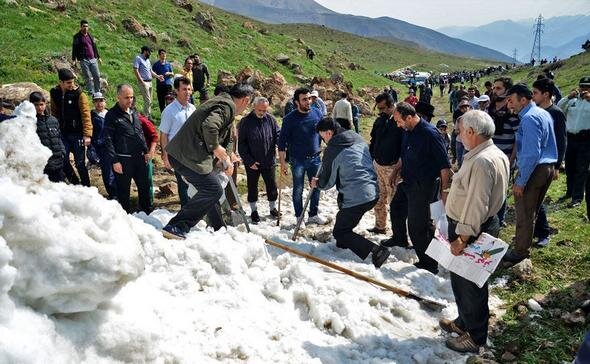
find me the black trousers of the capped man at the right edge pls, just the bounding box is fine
[565,133,590,201]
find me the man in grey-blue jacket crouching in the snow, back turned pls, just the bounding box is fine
[311,117,389,268]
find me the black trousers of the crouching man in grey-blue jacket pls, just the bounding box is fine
[332,198,379,260]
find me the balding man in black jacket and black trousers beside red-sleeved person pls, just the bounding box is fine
[105,85,153,214]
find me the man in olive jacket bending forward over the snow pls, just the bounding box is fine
[163,84,254,239]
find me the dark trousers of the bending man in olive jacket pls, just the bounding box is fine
[168,155,224,233]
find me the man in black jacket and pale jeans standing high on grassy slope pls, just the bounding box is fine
[72,20,102,96]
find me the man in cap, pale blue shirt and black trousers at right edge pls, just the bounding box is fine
[557,76,590,213]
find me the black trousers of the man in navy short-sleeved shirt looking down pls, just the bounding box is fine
[389,179,438,274]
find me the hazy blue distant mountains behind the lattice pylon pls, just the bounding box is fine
[437,15,590,62]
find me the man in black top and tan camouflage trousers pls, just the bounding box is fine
[368,93,403,234]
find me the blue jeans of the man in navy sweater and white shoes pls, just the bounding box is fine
[290,154,322,216]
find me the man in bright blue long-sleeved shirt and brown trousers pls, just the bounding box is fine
[504,84,557,264]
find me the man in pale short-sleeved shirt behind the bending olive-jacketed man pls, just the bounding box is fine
[160,76,196,206]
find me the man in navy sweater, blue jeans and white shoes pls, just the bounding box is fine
[278,87,327,225]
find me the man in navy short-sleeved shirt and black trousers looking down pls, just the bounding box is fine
[388,102,451,274]
